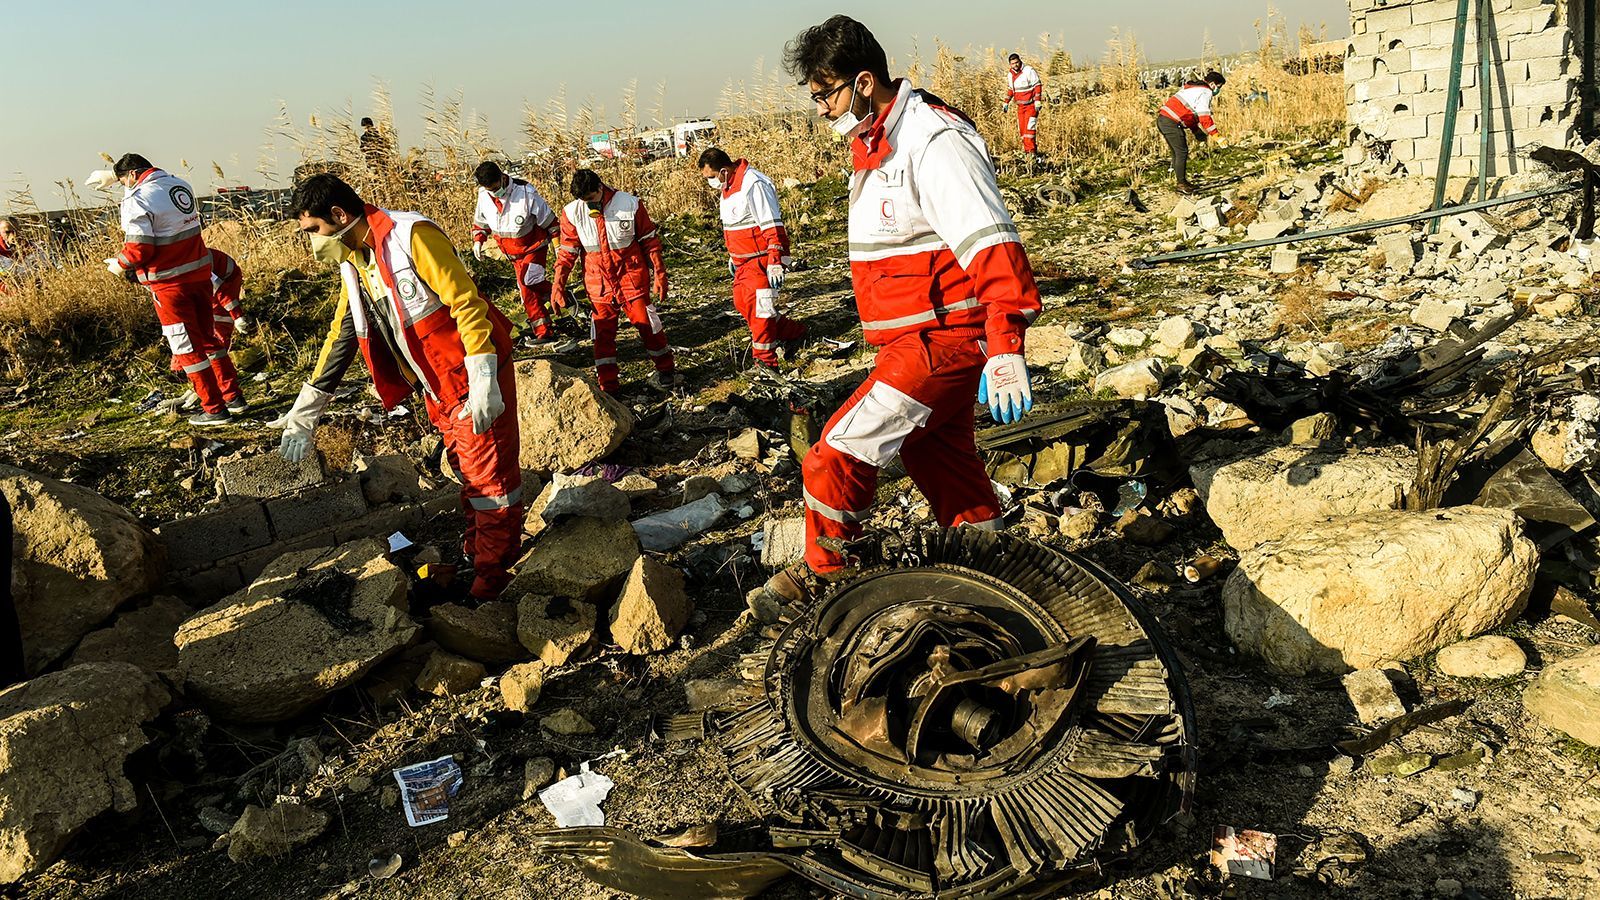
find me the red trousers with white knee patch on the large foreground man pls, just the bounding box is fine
[802,330,1000,573]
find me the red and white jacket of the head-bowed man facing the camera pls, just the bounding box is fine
[554,187,667,303]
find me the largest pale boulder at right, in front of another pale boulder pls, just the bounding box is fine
[1222,506,1539,674]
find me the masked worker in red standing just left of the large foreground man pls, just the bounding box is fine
[699,147,805,367]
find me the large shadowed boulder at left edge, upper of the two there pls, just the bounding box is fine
[0,466,166,671]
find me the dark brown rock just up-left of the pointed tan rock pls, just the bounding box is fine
[506,517,640,604]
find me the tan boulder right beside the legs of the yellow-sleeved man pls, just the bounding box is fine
[517,359,634,472]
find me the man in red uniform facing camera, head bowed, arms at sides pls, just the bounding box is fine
[554,168,677,394]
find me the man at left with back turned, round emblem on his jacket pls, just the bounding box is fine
[90,154,250,426]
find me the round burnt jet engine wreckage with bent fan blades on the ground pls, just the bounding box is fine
[538,528,1195,900]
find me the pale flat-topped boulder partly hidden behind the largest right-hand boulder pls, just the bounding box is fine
[1189,447,1416,552]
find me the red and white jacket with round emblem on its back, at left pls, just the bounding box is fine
[117,168,211,285]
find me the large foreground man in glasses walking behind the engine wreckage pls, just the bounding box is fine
[766,16,1040,601]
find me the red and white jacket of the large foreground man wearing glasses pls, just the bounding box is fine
[850,78,1040,356]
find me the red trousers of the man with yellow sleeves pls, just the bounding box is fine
[427,359,526,601]
